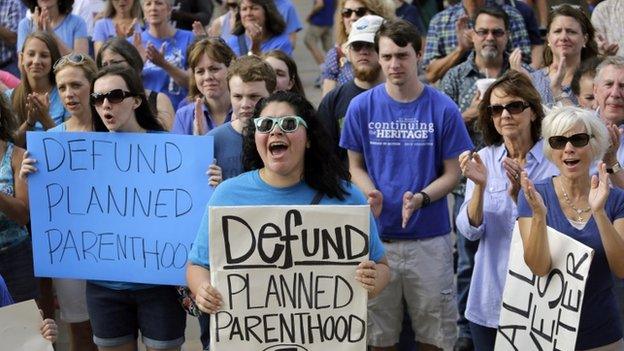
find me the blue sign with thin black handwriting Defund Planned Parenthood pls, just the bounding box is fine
[27,132,213,285]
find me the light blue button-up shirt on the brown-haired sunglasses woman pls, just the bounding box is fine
[456,140,559,328]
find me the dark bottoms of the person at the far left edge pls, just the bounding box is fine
[0,236,39,302]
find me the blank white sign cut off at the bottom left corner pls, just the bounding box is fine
[0,300,54,351]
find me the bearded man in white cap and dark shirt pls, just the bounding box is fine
[317,15,384,164]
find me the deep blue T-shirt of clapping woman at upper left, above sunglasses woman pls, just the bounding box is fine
[141,29,194,106]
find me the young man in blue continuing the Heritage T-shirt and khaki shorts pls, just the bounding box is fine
[340,20,473,351]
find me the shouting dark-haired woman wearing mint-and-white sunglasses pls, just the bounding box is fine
[187,91,390,313]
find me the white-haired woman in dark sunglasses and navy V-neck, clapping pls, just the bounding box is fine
[518,107,624,351]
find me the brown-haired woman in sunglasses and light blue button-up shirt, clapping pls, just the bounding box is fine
[456,70,557,350]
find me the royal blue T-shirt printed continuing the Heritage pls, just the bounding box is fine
[340,84,473,239]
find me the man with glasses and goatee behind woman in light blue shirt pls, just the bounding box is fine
[440,7,530,351]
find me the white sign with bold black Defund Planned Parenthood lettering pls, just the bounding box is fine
[209,205,370,351]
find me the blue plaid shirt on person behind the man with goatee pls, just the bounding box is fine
[423,0,531,68]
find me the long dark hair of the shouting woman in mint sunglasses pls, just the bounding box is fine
[243,91,351,200]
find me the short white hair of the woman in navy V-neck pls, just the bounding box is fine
[542,106,611,163]
